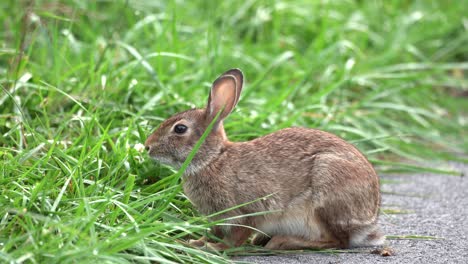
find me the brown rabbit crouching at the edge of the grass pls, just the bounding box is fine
[145,69,385,250]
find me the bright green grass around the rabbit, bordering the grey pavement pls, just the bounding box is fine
[0,0,468,263]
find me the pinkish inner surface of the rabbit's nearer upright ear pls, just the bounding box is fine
[210,75,237,119]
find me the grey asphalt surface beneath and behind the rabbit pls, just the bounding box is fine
[238,163,468,264]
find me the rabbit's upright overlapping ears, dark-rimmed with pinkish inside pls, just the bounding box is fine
[206,69,243,124]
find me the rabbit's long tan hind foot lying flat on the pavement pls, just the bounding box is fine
[265,235,342,250]
